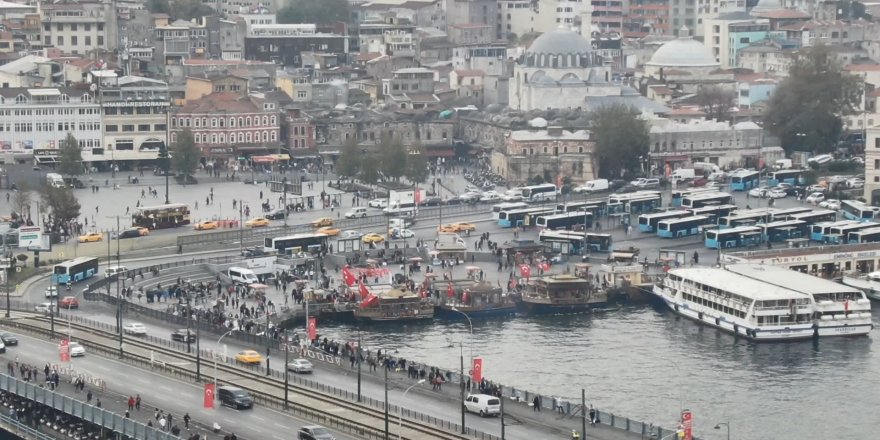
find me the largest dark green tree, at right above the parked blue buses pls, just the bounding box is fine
[764,45,861,153]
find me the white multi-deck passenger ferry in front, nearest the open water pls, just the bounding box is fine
[654,267,814,341]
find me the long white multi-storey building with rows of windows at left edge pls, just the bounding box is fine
[0,88,101,162]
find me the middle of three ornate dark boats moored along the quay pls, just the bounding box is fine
[434,280,516,320]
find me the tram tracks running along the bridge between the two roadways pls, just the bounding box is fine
[2,315,478,440]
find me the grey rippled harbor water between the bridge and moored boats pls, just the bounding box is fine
[319,306,880,440]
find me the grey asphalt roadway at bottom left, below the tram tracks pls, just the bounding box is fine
[0,334,354,440]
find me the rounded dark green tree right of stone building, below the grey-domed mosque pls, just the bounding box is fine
[591,104,650,178]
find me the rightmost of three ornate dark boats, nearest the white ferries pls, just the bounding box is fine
[518,275,608,314]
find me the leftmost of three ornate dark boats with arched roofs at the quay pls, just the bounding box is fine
[354,288,434,322]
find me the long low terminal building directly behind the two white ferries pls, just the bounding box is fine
[721,243,880,278]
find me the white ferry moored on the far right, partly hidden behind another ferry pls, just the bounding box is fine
[725,264,874,336]
